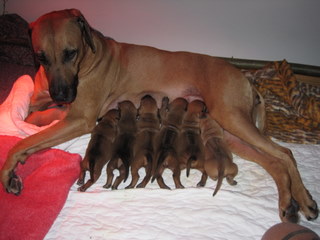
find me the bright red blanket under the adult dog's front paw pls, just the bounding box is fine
[0,136,81,240]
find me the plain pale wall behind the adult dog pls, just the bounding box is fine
[0,0,320,66]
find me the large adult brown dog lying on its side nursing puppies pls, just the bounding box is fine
[0,9,318,222]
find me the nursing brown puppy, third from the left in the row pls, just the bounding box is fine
[126,95,160,188]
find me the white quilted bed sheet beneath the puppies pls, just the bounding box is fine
[45,135,320,240]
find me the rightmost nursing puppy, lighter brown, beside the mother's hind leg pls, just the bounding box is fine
[200,112,238,196]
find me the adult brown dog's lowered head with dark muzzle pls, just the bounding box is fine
[30,9,96,104]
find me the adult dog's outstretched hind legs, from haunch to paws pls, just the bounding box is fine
[201,72,319,222]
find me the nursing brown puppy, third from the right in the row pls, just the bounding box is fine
[152,98,188,189]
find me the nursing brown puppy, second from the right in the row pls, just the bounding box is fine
[179,100,207,187]
